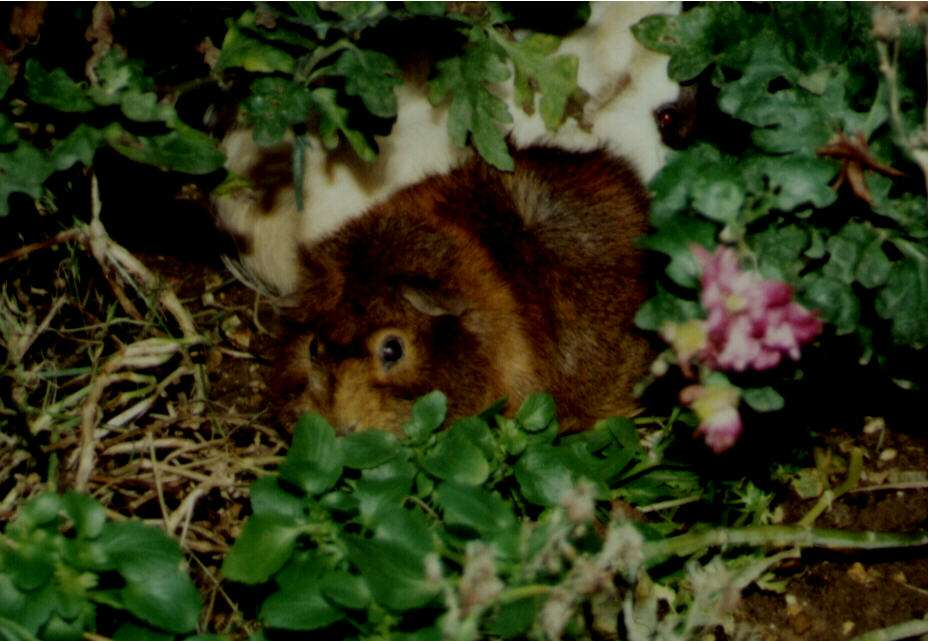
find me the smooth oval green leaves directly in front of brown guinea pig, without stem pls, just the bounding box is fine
[223,392,763,638]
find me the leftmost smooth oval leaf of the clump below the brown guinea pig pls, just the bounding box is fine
[222,514,301,584]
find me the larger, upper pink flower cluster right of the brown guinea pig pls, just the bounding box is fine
[692,245,822,372]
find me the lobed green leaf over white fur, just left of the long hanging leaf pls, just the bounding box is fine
[334,49,403,118]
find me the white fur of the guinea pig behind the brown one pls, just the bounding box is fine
[215,2,679,295]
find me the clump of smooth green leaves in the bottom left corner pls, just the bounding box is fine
[0,492,201,641]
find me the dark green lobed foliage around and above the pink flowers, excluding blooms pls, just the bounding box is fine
[633,3,928,388]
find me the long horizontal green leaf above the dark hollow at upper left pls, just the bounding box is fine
[104,123,225,174]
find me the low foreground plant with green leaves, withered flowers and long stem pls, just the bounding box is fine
[223,392,928,641]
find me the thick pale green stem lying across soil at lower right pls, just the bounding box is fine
[644,525,928,565]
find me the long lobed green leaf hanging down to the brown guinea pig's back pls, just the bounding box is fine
[429,27,514,171]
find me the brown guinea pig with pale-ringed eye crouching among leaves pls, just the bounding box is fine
[276,147,651,433]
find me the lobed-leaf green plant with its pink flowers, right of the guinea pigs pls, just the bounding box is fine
[633,3,928,450]
